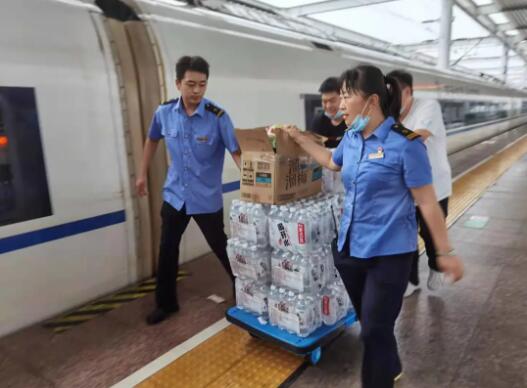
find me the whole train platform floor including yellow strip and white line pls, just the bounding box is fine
[0,128,527,388]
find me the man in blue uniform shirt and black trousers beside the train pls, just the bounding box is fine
[136,56,240,325]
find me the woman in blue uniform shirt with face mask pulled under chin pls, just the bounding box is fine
[287,65,463,388]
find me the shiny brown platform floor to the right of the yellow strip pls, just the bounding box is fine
[292,153,527,388]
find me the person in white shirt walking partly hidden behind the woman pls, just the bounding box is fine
[388,70,452,296]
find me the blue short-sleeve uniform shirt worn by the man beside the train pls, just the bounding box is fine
[148,98,239,214]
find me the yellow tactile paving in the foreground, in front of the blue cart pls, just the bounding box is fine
[139,325,303,388]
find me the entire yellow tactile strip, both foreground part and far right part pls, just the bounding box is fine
[139,137,527,388]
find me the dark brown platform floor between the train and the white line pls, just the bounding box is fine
[0,255,234,388]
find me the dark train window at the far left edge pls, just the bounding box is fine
[0,86,52,226]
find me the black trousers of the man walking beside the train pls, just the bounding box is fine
[156,202,234,312]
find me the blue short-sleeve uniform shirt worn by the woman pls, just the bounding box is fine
[333,117,432,259]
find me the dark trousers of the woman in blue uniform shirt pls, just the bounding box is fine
[335,252,414,388]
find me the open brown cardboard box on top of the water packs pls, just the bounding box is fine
[236,127,322,204]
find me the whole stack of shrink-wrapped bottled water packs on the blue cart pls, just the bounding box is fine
[227,193,351,337]
